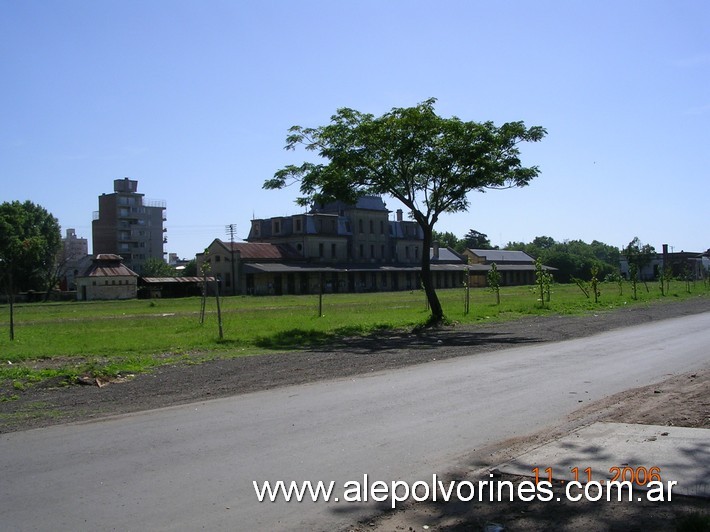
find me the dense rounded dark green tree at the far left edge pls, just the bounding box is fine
[0,201,62,339]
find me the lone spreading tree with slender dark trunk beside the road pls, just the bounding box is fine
[264,98,546,324]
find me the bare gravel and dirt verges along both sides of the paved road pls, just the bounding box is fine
[0,297,710,531]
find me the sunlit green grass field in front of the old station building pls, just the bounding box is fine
[0,281,710,399]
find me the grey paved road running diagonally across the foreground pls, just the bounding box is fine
[0,313,710,531]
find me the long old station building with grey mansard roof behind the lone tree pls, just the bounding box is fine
[197,196,465,295]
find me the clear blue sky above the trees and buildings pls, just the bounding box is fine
[0,0,710,257]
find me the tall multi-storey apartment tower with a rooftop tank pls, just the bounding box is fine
[92,177,167,273]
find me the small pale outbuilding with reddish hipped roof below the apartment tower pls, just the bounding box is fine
[76,253,138,301]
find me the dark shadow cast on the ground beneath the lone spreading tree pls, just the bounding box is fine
[256,327,540,353]
